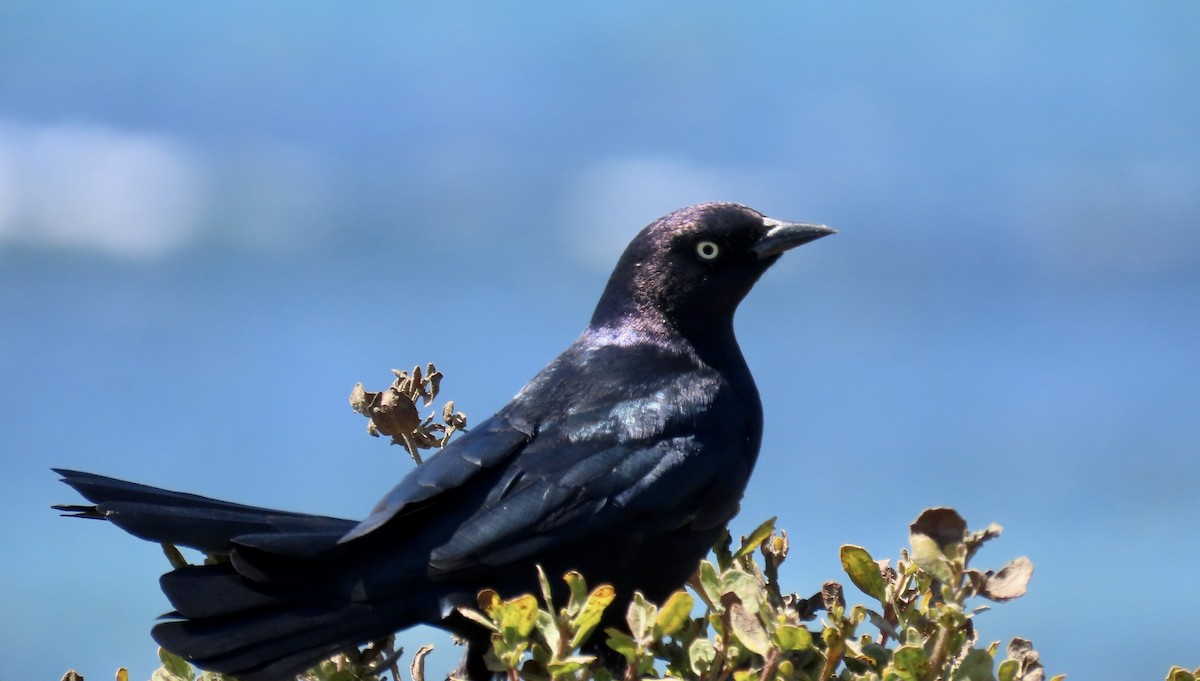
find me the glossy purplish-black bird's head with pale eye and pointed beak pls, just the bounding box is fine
[590,203,834,339]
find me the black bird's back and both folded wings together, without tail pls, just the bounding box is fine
[342,346,749,582]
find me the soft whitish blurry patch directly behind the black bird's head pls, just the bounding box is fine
[560,157,782,271]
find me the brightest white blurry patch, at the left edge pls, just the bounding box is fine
[0,121,204,259]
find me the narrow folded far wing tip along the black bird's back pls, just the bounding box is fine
[340,415,532,543]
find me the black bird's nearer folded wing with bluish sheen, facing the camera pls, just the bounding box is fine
[430,349,752,578]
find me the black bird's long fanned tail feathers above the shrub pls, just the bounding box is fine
[55,469,437,681]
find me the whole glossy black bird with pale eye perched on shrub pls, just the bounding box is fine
[51,203,833,681]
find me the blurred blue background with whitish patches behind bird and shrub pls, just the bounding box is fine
[0,1,1200,681]
